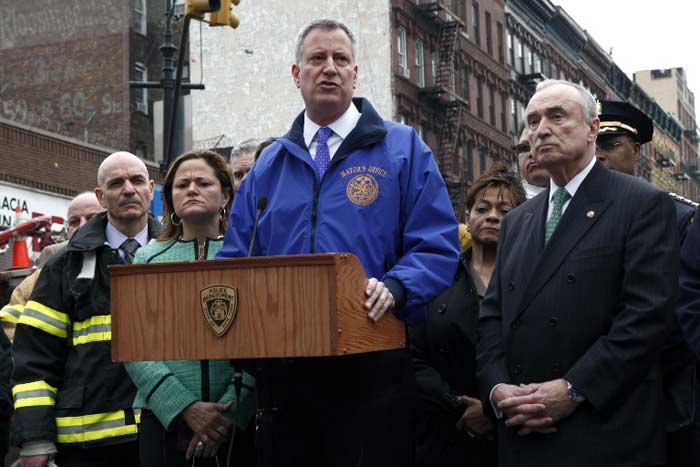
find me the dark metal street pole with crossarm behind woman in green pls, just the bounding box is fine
[129,0,204,176]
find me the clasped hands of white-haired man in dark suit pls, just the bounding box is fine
[491,378,578,436]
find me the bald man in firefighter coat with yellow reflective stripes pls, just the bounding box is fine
[12,152,158,467]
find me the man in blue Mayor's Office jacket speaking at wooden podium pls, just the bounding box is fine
[219,20,459,467]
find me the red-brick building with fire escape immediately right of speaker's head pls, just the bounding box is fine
[391,0,513,218]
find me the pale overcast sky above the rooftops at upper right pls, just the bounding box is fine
[552,0,700,119]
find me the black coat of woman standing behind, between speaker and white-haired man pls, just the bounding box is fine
[409,250,497,467]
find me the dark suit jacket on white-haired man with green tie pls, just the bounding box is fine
[477,163,678,467]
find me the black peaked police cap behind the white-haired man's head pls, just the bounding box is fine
[598,101,654,144]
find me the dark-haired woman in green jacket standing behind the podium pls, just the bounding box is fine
[126,151,255,466]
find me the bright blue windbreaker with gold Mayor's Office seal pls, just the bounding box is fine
[217,99,459,323]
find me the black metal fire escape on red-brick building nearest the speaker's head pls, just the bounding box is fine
[416,1,469,213]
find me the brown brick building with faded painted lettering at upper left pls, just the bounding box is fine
[0,0,164,159]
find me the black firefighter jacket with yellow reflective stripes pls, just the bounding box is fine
[12,213,157,448]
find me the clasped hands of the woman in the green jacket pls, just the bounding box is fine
[182,401,233,459]
